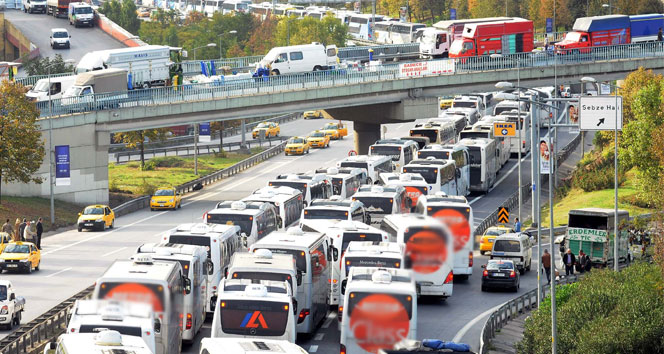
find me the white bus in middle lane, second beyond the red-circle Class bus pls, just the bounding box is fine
[302,220,395,306]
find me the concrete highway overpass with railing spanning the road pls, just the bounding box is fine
[3,43,664,203]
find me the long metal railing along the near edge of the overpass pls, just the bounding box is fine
[38,42,664,119]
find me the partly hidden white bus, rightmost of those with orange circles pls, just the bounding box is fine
[415,194,475,280]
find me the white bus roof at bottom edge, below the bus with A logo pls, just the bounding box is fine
[199,338,307,354]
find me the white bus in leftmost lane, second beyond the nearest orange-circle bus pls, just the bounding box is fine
[162,223,242,315]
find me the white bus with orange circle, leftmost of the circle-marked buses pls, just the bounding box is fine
[92,256,185,354]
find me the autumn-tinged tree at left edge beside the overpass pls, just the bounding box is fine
[0,80,44,203]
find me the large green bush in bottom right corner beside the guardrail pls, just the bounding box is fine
[517,263,664,354]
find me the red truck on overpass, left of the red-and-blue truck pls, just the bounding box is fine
[449,18,534,58]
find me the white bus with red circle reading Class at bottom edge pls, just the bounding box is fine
[340,267,417,354]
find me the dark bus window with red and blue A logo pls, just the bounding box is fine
[220,300,292,337]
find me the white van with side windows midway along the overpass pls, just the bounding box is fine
[257,42,339,75]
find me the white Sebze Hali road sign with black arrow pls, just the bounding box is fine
[579,96,622,130]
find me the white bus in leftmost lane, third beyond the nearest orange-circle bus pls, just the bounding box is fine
[208,200,281,247]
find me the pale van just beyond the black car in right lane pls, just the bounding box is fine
[490,233,533,274]
